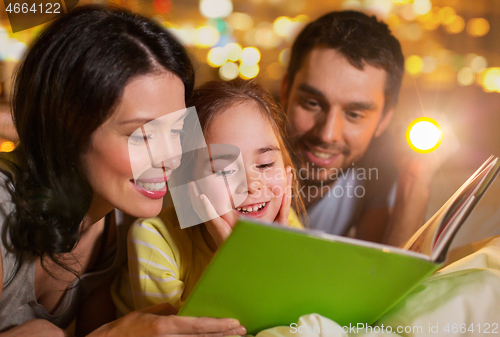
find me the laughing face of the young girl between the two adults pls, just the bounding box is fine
[205,102,286,221]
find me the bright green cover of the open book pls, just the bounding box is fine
[179,220,439,334]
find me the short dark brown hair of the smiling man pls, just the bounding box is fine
[287,11,404,112]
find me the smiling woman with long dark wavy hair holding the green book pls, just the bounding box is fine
[0,7,244,336]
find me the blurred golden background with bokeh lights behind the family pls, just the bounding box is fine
[0,0,500,244]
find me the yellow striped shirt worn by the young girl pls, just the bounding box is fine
[128,207,303,309]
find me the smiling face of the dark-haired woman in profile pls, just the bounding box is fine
[82,72,185,217]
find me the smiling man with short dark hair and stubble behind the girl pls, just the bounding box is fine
[281,11,428,244]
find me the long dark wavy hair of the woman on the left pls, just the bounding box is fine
[6,6,194,269]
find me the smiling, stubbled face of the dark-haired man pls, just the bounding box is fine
[281,47,392,184]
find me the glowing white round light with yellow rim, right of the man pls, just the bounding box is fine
[406,117,443,153]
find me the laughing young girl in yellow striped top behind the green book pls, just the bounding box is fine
[128,80,304,309]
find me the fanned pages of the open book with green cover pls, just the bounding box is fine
[403,156,498,257]
